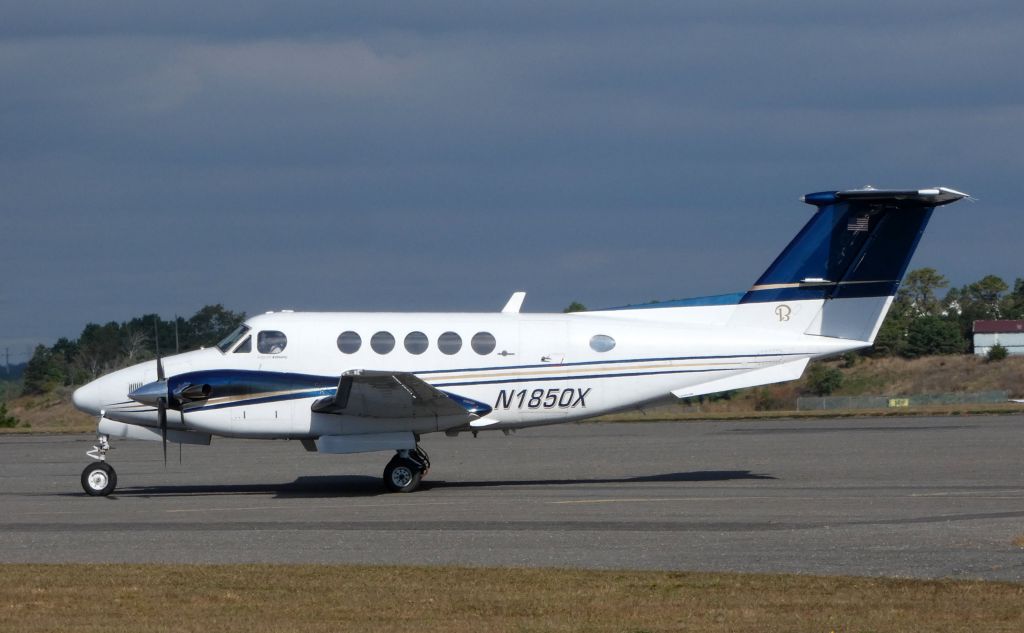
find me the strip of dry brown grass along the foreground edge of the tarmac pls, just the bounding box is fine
[0,564,1024,633]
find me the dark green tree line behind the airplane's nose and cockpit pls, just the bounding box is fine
[23,303,246,394]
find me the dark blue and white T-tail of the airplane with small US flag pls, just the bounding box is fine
[729,187,967,344]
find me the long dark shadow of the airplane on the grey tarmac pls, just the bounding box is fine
[86,470,775,499]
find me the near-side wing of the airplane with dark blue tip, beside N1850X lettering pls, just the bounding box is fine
[312,370,490,420]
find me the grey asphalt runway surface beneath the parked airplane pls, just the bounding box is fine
[0,415,1024,581]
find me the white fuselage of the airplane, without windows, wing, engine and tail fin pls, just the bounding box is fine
[70,302,867,438]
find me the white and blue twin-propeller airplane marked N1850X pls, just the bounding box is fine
[73,187,967,496]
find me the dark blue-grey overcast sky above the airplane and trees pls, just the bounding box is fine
[0,0,1024,361]
